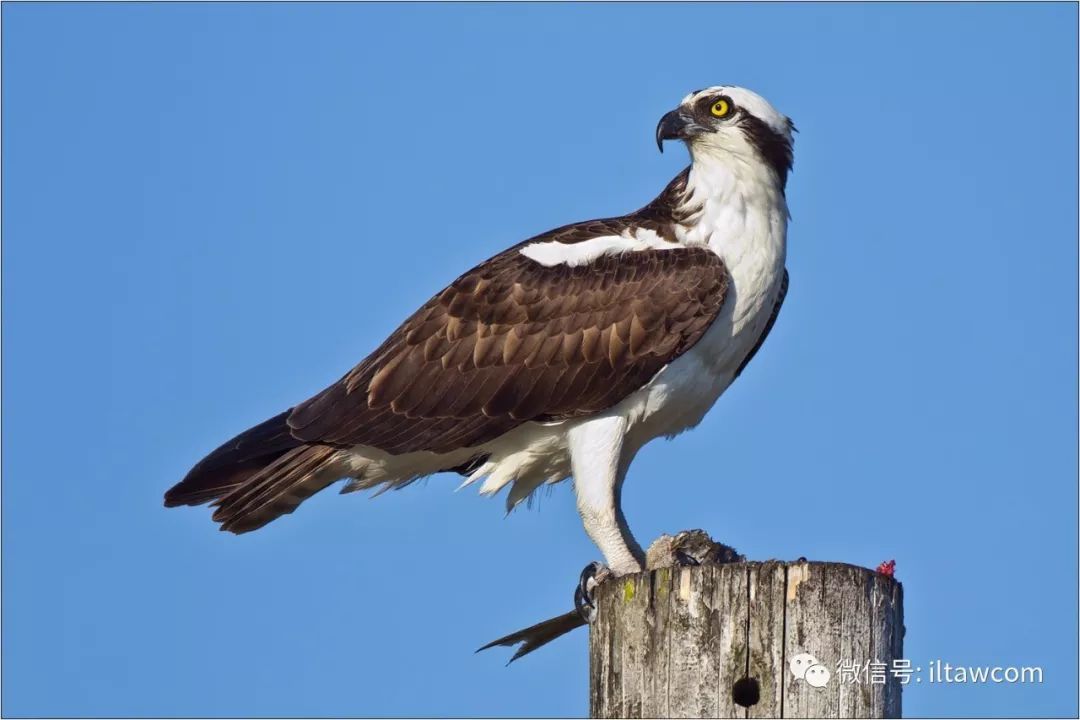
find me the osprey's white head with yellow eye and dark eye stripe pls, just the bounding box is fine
[657,85,795,188]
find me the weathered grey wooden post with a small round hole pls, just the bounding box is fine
[589,561,914,718]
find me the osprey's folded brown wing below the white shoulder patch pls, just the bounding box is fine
[288,246,728,454]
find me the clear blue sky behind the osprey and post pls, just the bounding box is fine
[2,3,1078,716]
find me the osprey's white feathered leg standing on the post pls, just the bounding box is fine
[568,416,645,576]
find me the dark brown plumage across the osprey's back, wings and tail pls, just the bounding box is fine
[165,171,743,533]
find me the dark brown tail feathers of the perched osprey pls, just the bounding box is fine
[165,411,339,533]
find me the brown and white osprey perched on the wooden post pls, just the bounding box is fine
[165,86,794,575]
